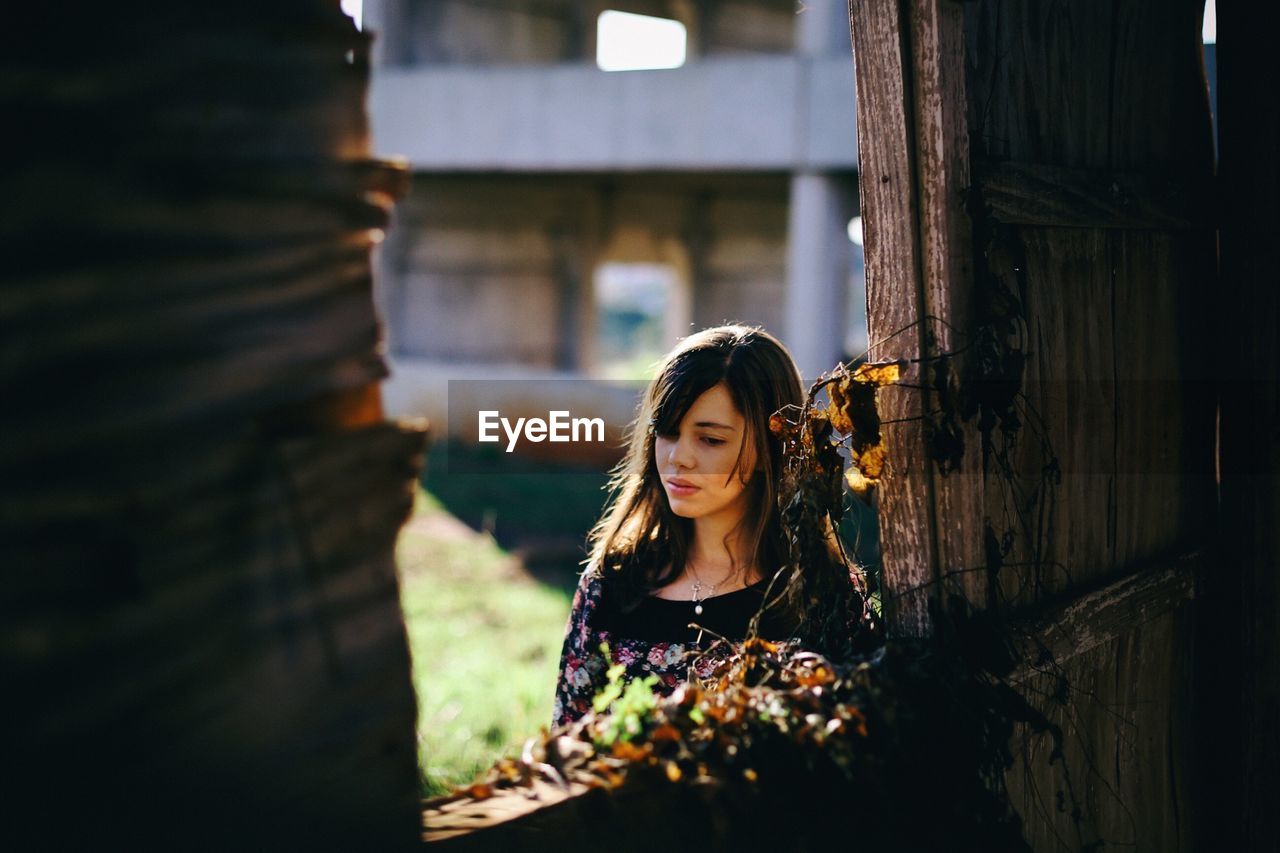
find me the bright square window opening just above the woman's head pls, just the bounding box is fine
[595,263,680,379]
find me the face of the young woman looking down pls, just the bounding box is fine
[653,382,755,523]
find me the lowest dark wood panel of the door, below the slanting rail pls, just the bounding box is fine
[1005,606,1198,853]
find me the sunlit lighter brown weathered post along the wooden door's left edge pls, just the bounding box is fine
[850,0,987,637]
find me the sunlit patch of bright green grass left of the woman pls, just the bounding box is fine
[398,492,570,795]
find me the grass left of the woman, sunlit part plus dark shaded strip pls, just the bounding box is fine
[398,443,608,795]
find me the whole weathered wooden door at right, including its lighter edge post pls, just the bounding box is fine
[850,0,1216,849]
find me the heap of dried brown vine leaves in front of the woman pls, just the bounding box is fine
[428,622,1049,850]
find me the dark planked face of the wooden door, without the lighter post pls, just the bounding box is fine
[965,1,1215,850]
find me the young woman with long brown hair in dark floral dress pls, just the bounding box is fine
[553,325,860,725]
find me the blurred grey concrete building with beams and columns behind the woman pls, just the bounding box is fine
[364,0,865,425]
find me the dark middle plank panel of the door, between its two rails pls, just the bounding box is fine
[987,219,1212,606]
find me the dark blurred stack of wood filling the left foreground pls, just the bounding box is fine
[0,0,422,850]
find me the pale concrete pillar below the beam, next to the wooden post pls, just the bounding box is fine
[783,172,850,380]
